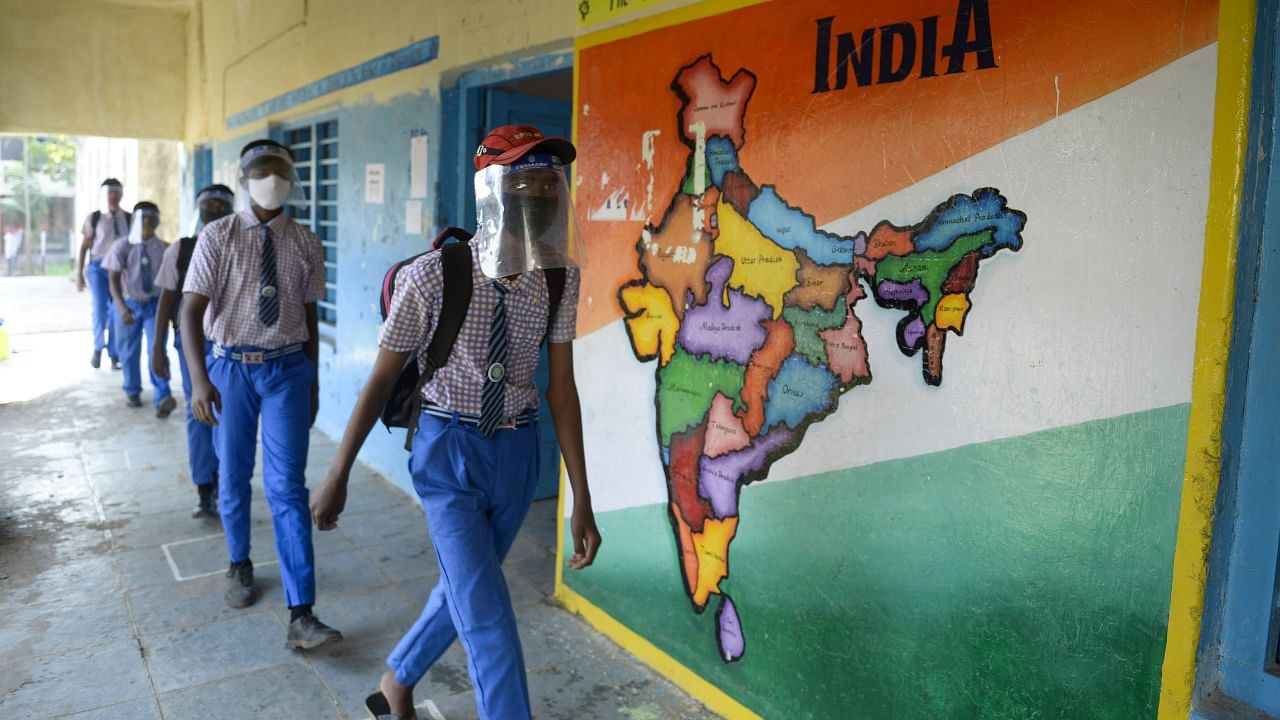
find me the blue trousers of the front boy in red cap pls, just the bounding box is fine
[387,414,540,720]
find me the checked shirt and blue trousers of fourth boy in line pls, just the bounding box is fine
[102,236,173,407]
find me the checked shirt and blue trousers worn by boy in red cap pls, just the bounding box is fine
[379,243,580,719]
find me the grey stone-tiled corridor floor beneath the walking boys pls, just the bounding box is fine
[0,278,714,720]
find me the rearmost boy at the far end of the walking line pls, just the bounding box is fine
[76,178,129,370]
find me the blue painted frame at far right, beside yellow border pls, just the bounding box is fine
[1196,0,1280,719]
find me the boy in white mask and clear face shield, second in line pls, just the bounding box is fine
[179,140,342,650]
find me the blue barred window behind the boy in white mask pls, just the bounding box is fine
[283,120,338,325]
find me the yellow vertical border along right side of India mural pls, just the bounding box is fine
[1158,0,1257,720]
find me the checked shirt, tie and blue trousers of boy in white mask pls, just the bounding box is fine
[183,210,325,607]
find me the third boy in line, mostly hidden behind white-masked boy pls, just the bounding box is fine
[151,184,236,518]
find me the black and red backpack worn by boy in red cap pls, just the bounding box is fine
[379,228,564,450]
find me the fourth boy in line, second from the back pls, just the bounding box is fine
[102,202,178,418]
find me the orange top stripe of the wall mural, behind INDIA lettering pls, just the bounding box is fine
[575,0,1217,334]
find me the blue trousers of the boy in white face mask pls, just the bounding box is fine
[206,347,316,607]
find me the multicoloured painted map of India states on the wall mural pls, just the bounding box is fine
[618,55,1027,662]
